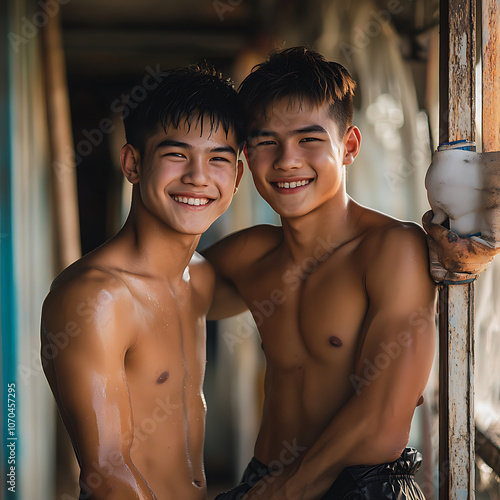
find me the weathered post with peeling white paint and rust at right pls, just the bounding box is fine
[439,0,476,500]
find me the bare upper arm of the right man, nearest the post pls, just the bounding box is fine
[355,231,435,415]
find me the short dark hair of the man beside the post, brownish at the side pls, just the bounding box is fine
[239,47,356,137]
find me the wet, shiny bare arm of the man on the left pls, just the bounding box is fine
[42,280,155,500]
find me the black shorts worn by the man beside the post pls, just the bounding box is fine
[215,448,425,500]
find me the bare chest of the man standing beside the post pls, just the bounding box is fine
[238,249,368,369]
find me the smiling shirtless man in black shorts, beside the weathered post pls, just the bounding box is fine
[204,47,435,500]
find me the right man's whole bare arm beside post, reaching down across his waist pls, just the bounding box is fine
[249,226,435,499]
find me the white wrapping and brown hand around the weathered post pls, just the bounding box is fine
[422,149,500,283]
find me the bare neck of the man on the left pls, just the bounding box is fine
[116,193,201,281]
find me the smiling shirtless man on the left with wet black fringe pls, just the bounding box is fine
[41,68,243,500]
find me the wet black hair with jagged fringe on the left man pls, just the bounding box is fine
[122,64,245,157]
